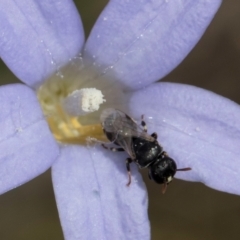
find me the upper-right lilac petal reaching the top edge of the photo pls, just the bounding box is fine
[85,0,221,89]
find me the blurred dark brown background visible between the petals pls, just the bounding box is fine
[0,0,240,240]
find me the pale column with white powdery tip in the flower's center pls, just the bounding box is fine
[62,88,106,116]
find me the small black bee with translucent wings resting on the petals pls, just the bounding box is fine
[100,108,191,193]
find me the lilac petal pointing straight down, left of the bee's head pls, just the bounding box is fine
[52,145,150,240]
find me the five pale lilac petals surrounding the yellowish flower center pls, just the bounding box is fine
[0,0,240,240]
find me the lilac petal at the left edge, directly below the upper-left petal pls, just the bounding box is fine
[0,84,59,193]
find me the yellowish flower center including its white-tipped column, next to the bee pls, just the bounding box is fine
[37,57,124,144]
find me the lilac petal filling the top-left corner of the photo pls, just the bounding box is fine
[0,0,84,86]
